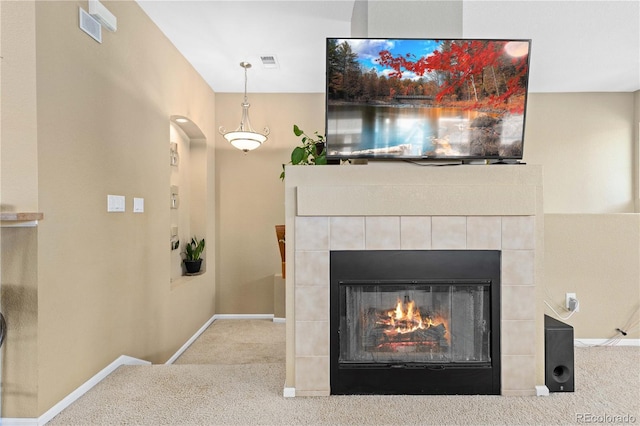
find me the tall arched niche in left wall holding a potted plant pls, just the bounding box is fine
[167,115,207,287]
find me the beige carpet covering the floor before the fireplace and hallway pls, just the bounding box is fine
[49,320,640,426]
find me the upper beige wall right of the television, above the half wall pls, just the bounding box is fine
[524,93,637,213]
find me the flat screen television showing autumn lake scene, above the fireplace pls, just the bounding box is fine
[326,38,531,162]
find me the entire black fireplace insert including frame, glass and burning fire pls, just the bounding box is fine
[330,250,500,395]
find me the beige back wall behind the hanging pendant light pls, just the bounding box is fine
[216,93,324,314]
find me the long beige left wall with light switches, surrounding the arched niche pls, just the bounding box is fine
[2,1,216,417]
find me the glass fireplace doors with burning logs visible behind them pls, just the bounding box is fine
[339,280,491,366]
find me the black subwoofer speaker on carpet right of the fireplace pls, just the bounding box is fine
[544,315,574,392]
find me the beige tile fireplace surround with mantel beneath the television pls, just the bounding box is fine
[284,162,544,396]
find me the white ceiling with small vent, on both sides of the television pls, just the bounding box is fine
[137,0,640,93]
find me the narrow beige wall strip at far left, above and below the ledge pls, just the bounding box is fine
[0,2,38,417]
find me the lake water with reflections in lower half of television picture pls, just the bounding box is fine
[327,105,524,158]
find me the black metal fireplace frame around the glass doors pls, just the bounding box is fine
[330,250,501,395]
